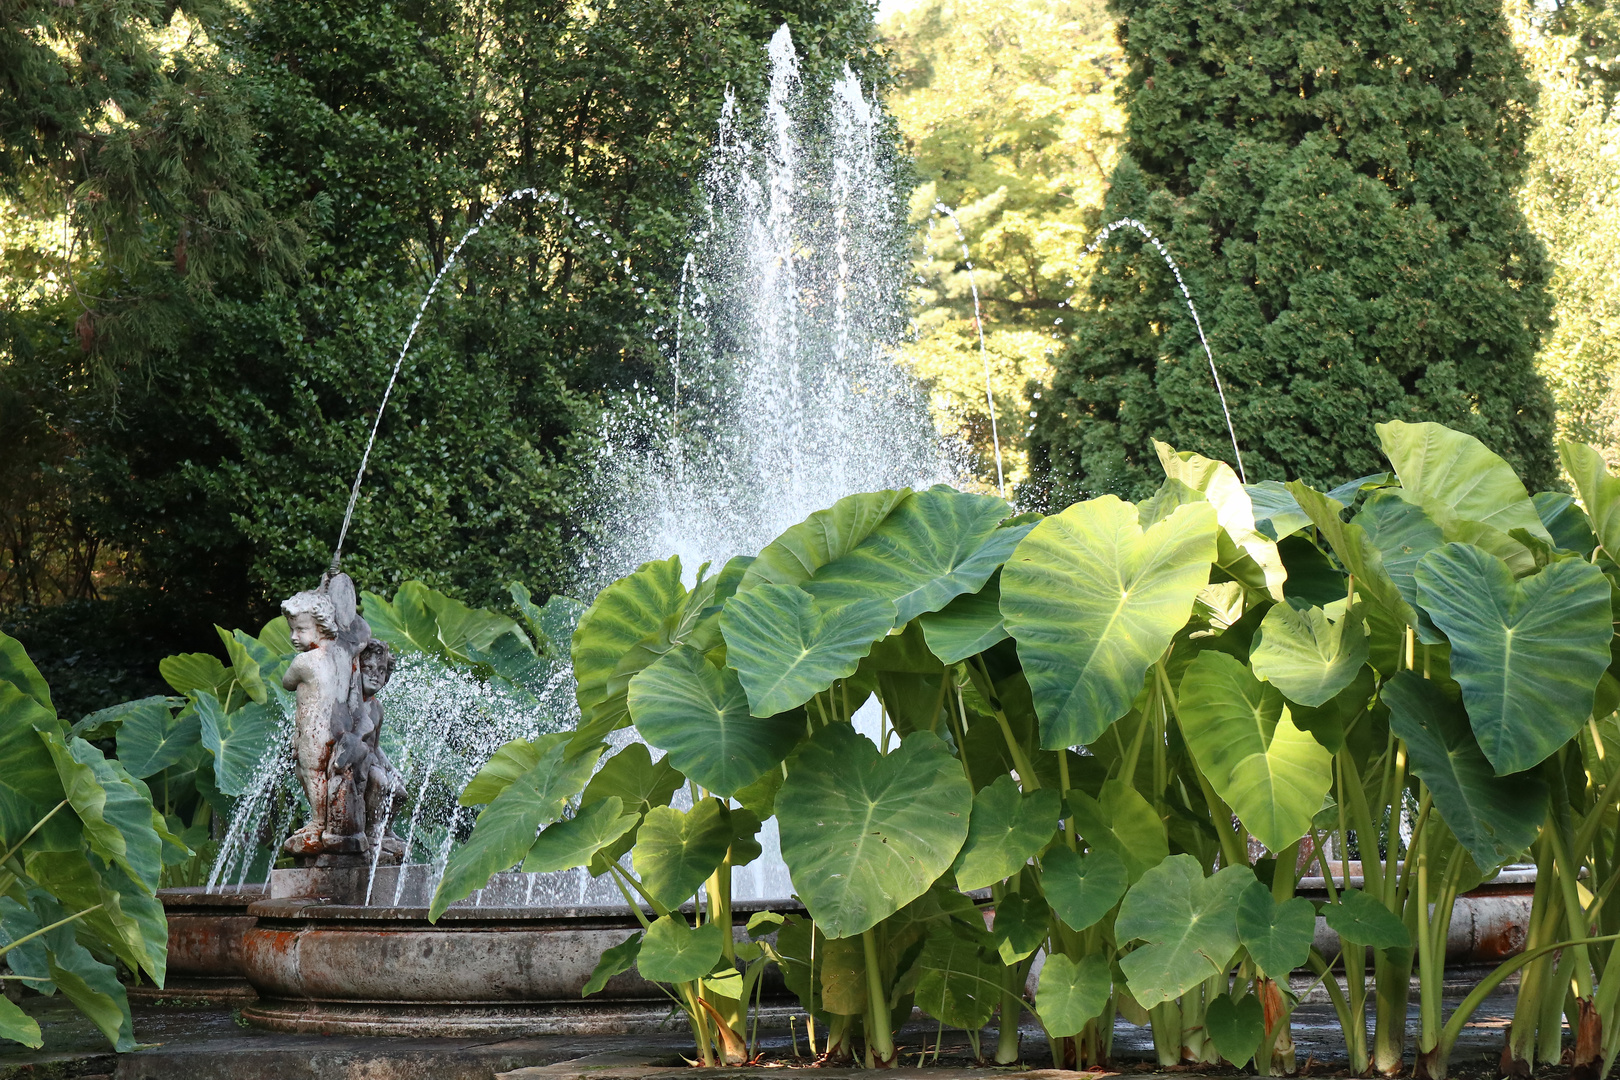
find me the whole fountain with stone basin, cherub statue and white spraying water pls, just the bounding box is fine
[166,26,954,1035]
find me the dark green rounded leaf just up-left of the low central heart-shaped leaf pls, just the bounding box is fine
[629,644,805,798]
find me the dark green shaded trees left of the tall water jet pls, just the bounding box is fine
[0,0,873,712]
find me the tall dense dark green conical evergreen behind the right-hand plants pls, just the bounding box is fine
[1025,0,1555,507]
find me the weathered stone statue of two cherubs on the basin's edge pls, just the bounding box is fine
[282,572,403,863]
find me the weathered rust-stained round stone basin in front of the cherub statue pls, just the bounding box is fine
[241,899,797,1038]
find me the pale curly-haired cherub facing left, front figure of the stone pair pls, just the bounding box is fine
[282,573,371,855]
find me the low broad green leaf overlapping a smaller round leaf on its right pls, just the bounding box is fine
[1115,855,1254,1009]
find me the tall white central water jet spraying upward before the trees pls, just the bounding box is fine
[580,26,956,582]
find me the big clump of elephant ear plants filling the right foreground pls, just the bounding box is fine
[433,423,1620,1077]
